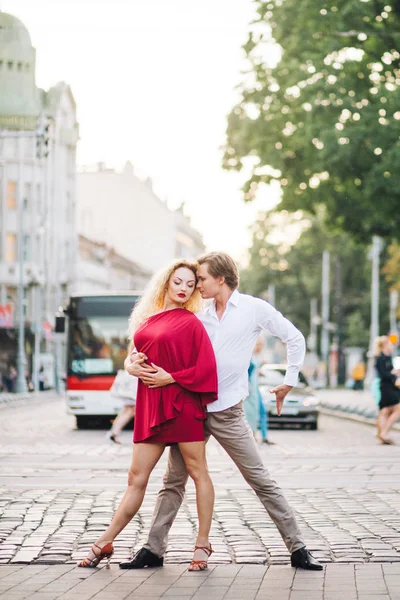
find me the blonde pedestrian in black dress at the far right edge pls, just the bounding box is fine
[374,335,400,445]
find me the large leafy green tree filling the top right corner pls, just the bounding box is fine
[223,0,400,243]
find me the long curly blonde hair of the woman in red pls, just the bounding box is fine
[128,260,202,342]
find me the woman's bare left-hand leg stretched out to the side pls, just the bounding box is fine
[96,444,165,547]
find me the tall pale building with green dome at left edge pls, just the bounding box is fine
[0,12,78,380]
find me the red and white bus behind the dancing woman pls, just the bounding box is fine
[65,292,140,428]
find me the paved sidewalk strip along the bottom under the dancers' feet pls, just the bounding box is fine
[0,564,400,600]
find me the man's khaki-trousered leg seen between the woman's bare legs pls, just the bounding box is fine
[144,445,188,556]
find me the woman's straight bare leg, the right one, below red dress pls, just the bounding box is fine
[179,442,214,561]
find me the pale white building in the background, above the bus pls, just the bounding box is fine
[77,162,205,272]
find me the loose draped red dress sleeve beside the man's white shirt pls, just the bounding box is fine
[170,319,218,404]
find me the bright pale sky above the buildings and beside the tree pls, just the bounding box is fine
[0,0,278,261]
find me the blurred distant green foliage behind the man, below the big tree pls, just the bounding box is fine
[241,211,389,348]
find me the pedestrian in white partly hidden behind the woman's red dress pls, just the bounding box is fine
[106,369,138,444]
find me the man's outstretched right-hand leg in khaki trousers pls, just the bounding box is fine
[207,402,305,553]
